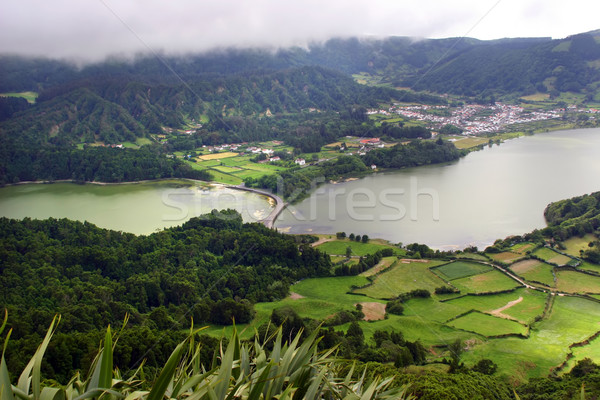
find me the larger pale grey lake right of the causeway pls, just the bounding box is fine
[275,129,600,249]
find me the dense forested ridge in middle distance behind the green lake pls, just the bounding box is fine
[0,67,404,144]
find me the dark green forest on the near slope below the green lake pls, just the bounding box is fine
[0,211,331,374]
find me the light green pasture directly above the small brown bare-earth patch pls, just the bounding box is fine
[353,261,446,299]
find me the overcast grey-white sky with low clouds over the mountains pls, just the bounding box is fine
[0,0,600,61]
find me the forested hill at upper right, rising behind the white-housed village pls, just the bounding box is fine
[404,34,600,96]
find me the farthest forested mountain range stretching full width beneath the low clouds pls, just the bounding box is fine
[0,31,600,97]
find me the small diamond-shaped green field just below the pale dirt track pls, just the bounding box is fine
[447,311,527,337]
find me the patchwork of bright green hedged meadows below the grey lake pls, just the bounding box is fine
[195,235,600,383]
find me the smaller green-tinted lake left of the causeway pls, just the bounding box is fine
[0,181,274,234]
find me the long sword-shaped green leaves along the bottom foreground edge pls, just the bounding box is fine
[0,317,414,400]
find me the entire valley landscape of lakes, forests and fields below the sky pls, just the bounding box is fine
[0,26,600,399]
